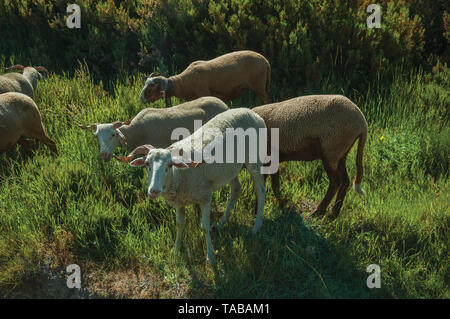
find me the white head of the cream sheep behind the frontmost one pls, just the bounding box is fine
[79,121,130,162]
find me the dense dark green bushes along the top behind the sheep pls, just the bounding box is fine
[0,0,448,97]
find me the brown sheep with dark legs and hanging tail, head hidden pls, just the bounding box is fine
[252,95,367,217]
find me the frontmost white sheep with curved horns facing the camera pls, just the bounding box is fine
[115,108,265,264]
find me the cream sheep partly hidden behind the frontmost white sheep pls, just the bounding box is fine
[80,96,228,162]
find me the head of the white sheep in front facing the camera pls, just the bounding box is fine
[114,144,202,199]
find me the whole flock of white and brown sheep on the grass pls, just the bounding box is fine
[0,51,367,264]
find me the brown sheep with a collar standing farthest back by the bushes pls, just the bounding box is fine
[140,51,270,107]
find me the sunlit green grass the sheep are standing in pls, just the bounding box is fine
[0,63,450,298]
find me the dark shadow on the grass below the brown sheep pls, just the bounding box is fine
[184,207,386,298]
